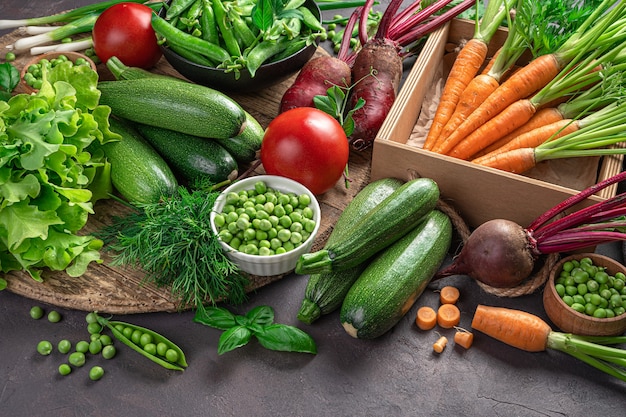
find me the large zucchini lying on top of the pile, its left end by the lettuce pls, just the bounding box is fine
[98,77,246,139]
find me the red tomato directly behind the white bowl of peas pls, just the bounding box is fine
[261,107,350,194]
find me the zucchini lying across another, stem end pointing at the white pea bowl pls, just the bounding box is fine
[295,178,439,275]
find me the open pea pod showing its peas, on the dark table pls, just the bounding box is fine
[98,316,187,371]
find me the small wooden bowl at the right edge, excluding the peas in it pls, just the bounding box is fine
[543,253,626,336]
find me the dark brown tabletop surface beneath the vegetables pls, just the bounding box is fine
[0,0,626,417]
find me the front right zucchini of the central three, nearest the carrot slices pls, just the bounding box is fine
[339,210,452,339]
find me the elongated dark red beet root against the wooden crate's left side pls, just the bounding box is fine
[348,38,402,149]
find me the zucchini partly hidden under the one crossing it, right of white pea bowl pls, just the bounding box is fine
[298,178,403,324]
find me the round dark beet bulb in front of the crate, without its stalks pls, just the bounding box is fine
[437,219,535,288]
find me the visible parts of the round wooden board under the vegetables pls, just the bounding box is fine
[0,30,371,314]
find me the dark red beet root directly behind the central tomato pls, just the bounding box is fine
[280,56,351,113]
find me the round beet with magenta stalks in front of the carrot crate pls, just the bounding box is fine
[436,171,626,288]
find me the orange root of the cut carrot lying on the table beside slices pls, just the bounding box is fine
[472,305,552,352]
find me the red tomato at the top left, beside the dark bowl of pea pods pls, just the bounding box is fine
[92,3,162,68]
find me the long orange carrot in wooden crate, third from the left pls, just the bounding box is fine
[432,54,562,156]
